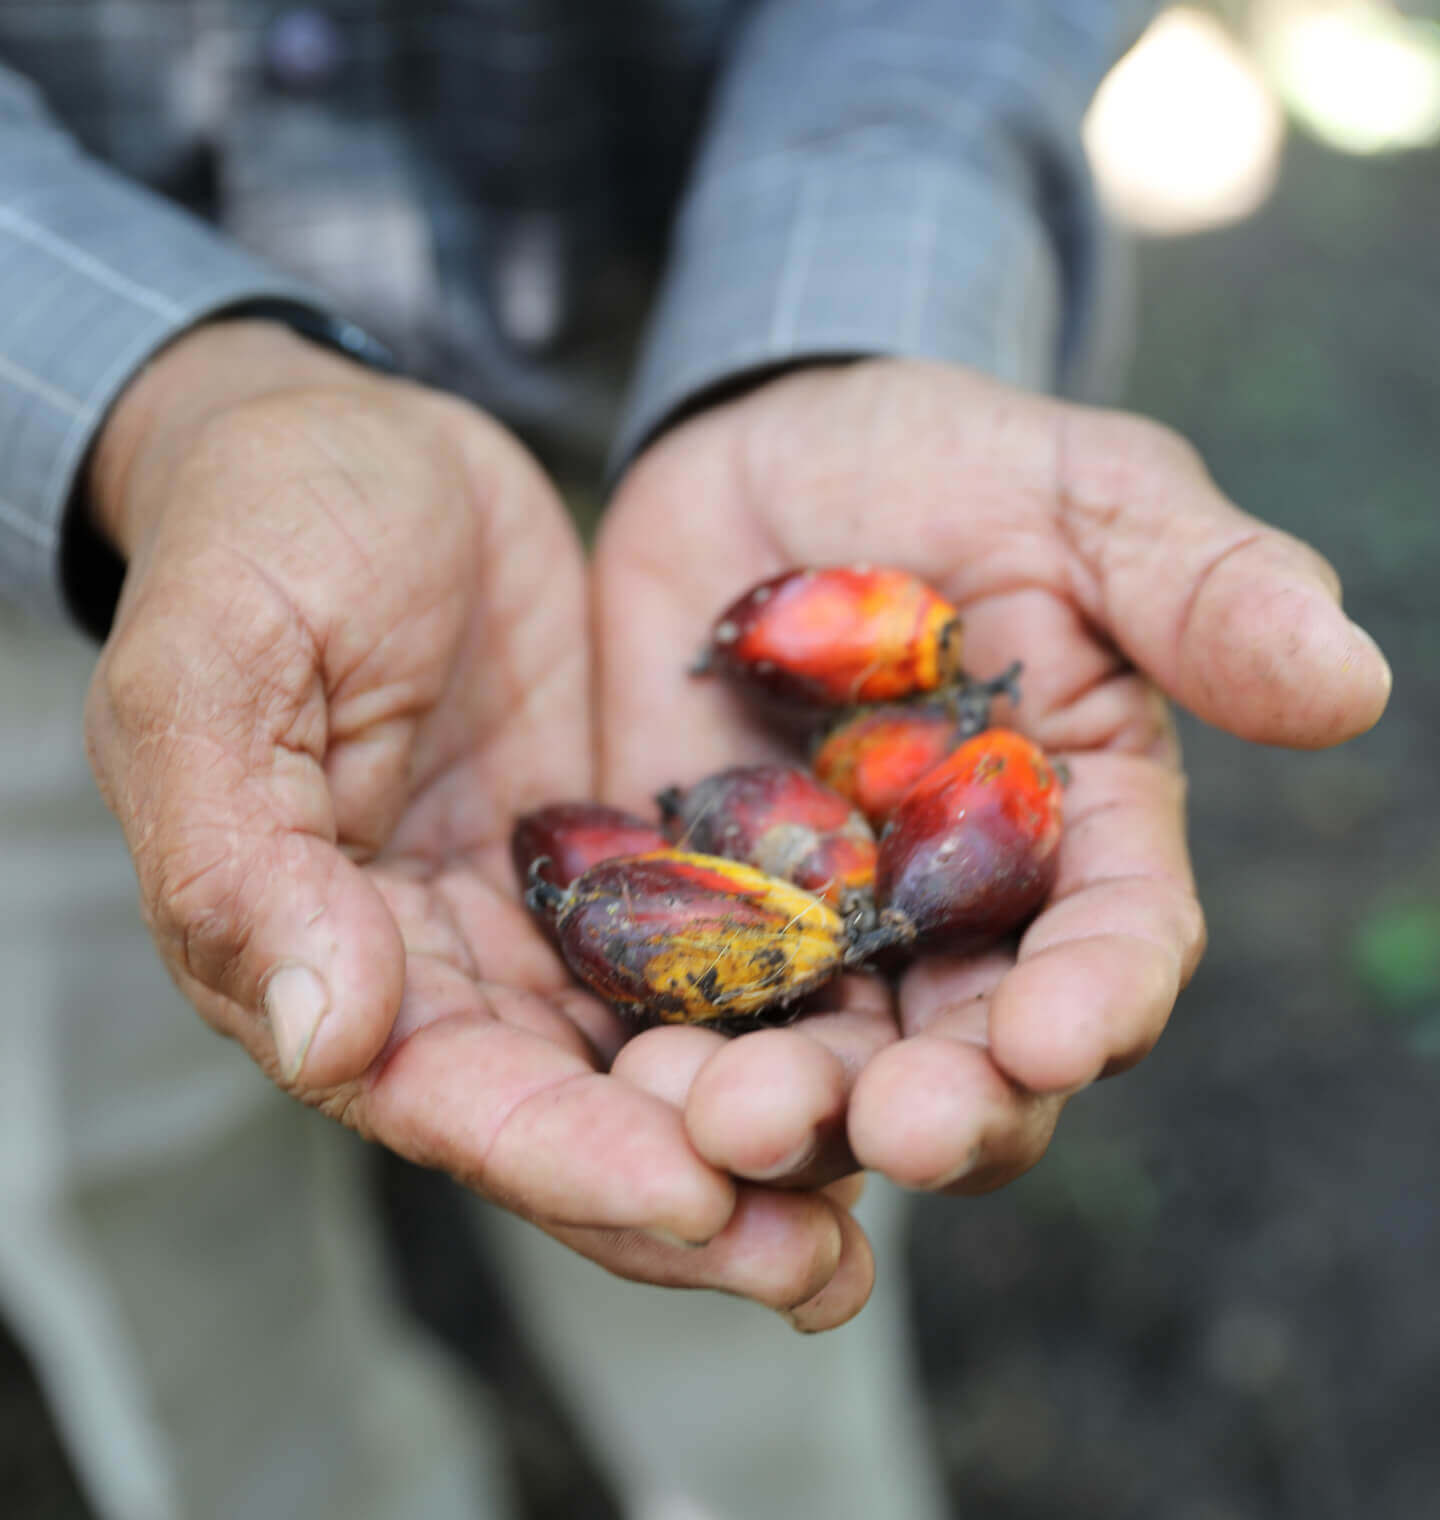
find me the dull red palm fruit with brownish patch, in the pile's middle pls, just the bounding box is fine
[657,765,876,912]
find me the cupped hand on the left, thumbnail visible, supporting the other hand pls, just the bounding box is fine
[87,322,871,1330]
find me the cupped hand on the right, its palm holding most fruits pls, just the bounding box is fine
[596,360,1390,1192]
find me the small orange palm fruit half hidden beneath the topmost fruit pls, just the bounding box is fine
[810,661,1020,828]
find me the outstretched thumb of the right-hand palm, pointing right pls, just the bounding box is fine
[1060,407,1391,749]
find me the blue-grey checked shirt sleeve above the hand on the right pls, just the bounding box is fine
[614,0,1153,465]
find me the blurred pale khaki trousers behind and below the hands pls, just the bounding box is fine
[0,614,944,1520]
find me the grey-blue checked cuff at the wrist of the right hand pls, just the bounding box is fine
[611,150,1063,473]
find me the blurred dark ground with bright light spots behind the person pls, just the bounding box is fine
[0,0,1440,1520]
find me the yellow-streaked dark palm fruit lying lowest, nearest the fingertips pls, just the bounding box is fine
[526,850,848,1024]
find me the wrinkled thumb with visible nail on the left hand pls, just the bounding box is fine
[85,565,404,1093]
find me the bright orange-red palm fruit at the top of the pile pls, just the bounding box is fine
[695,565,961,708]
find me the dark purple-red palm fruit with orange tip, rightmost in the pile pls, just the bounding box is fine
[876,728,1060,950]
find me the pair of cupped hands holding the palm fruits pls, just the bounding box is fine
[87,322,1390,1330]
